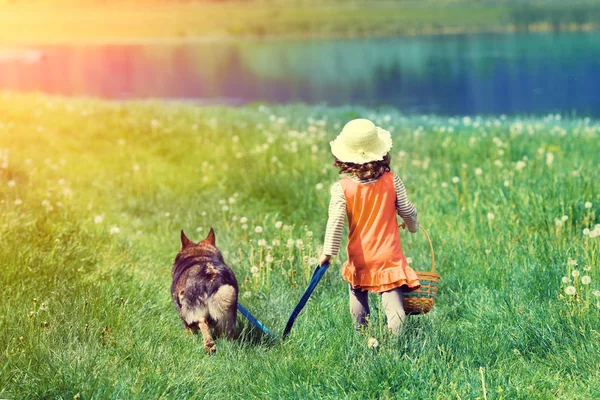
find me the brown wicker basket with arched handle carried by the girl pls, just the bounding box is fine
[402,227,440,315]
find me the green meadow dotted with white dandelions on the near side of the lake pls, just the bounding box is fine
[0,93,600,399]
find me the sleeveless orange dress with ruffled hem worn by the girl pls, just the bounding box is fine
[340,172,421,292]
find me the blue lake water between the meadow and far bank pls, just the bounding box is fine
[0,32,600,117]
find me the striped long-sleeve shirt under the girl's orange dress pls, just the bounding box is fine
[323,174,419,256]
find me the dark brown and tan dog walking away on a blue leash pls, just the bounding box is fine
[171,228,238,351]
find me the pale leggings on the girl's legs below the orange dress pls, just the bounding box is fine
[350,286,406,334]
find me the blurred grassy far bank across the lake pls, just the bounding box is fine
[0,0,600,45]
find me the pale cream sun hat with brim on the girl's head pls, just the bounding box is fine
[329,118,392,164]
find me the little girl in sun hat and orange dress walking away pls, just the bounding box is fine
[319,119,421,333]
